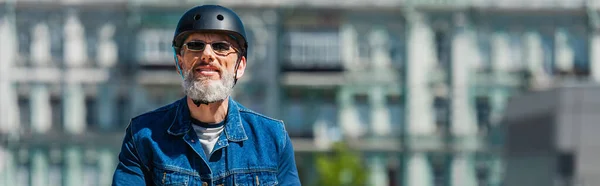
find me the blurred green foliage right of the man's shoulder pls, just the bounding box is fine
[316,143,368,186]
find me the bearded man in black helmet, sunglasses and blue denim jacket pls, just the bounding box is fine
[113,5,300,186]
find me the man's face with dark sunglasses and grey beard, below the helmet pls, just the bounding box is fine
[177,33,246,103]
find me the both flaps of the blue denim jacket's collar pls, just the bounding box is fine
[167,96,248,141]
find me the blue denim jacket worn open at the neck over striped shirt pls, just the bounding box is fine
[113,97,300,186]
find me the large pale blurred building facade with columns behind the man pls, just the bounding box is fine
[0,0,600,186]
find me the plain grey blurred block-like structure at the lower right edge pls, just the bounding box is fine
[503,83,600,186]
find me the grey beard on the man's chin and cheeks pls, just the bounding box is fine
[182,70,234,103]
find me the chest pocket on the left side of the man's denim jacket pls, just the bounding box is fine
[152,166,191,186]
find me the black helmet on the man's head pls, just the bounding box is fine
[172,5,248,57]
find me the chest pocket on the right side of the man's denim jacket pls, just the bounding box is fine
[233,171,279,186]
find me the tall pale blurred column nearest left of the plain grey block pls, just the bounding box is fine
[450,18,480,186]
